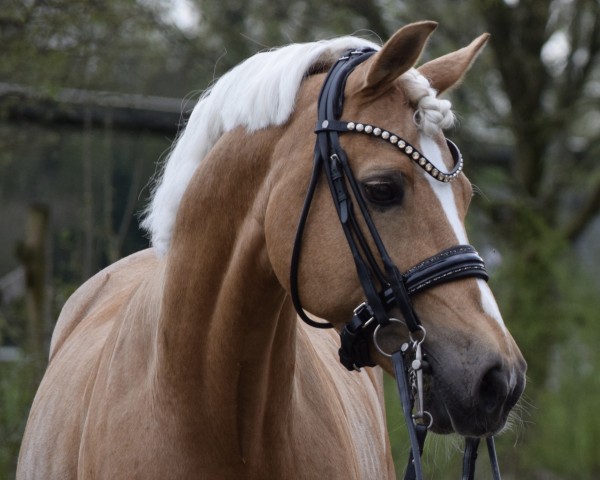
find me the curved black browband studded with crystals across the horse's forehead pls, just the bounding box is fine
[316,120,464,183]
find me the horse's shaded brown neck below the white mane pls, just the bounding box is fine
[158,126,296,438]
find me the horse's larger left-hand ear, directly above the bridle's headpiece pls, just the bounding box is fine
[363,21,437,90]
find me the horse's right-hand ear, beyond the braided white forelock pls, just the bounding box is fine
[418,33,490,93]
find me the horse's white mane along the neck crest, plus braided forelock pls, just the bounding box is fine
[141,37,454,255]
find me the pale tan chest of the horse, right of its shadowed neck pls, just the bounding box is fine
[297,322,395,479]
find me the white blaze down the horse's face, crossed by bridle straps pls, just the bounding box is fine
[419,134,506,332]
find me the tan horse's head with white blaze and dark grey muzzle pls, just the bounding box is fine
[265,22,526,437]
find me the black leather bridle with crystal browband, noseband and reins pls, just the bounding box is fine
[290,48,500,480]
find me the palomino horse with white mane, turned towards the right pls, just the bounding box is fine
[18,22,526,480]
